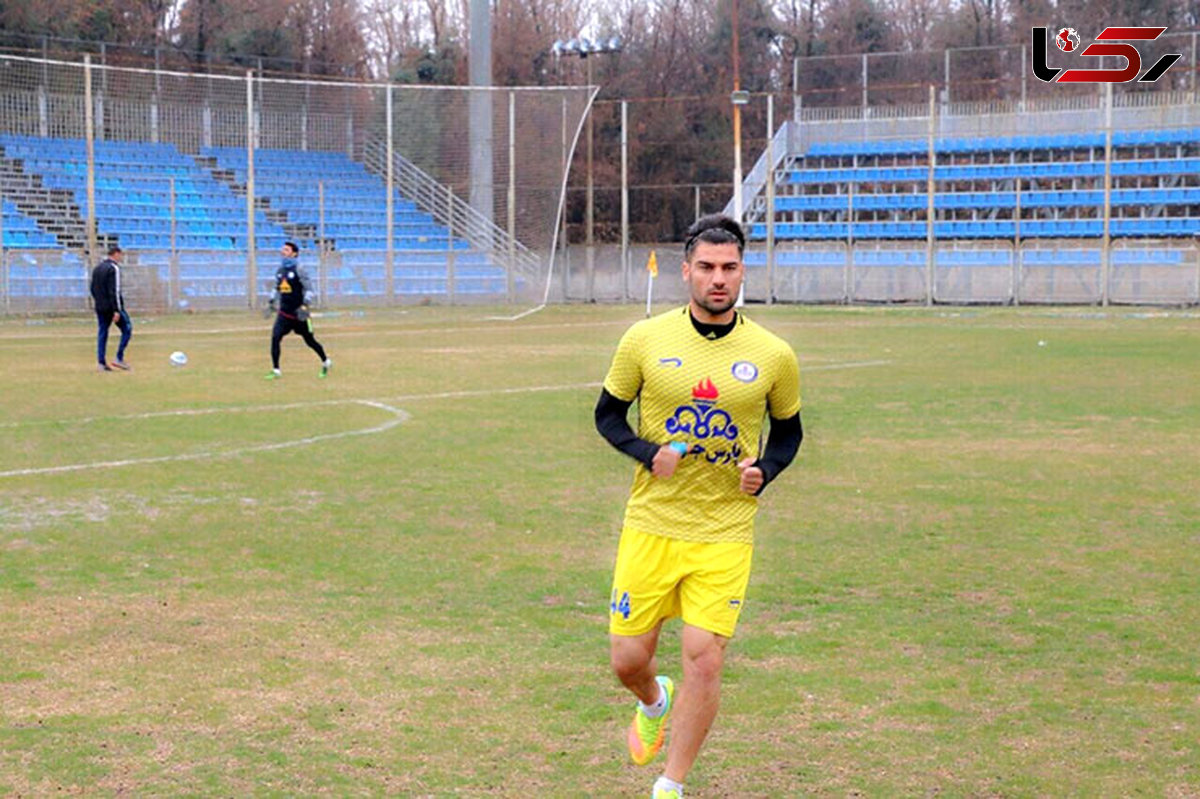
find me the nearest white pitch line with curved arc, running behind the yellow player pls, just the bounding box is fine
[0,361,892,477]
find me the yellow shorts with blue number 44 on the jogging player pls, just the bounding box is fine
[608,529,754,638]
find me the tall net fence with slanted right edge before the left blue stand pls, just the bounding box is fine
[0,56,593,308]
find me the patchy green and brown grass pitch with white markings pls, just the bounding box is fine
[0,307,1200,797]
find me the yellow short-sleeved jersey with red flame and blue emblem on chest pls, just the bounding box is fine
[604,306,800,543]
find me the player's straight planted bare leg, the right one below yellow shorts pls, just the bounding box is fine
[665,625,728,783]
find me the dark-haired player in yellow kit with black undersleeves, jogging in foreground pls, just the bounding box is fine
[595,215,803,799]
